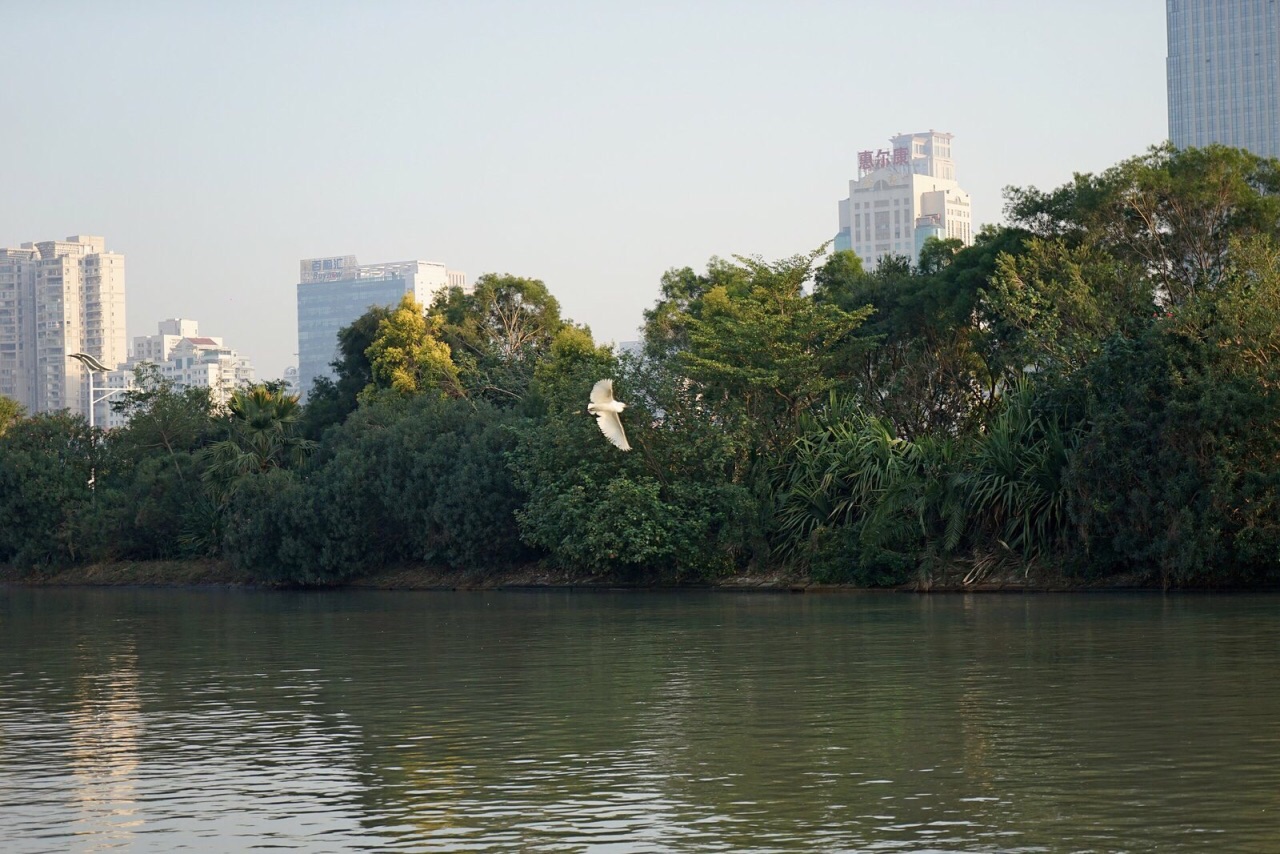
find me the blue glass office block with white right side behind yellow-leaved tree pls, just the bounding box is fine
[298,255,466,398]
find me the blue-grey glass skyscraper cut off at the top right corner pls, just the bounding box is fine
[1165,0,1280,157]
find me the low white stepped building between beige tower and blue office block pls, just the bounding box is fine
[99,318,255,429]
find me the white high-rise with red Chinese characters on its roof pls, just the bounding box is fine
[836,131,974,270]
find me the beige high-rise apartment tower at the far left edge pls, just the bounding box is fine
[0,234,127,424]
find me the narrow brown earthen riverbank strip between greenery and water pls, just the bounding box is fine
[0,560,1161,593]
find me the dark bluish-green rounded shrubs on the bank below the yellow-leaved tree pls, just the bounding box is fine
[224,392,531,584]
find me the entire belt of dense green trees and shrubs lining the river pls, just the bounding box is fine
[0,147,1280,585]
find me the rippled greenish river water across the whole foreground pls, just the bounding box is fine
[0,590,1280,851]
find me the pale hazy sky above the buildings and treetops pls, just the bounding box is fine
[0,0,1167,379]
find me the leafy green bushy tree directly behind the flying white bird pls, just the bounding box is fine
[509,326,750,577]
